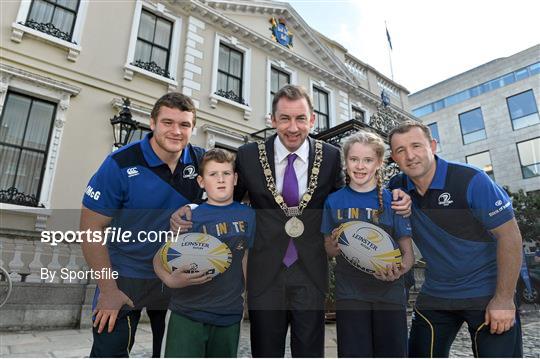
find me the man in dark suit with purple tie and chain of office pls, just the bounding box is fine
[235,85,344,357]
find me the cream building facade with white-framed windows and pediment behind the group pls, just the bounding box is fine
[0,0,412,328]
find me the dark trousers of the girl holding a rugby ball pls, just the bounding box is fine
[336,300,407,358]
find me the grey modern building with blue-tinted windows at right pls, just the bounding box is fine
[409,45,540,192]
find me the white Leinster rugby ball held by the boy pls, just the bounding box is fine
[161,233,232,277]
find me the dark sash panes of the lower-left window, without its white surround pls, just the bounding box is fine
[0,91,56,207]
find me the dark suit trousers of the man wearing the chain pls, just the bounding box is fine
[248,263,324,358]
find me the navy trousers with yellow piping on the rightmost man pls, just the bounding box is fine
[409,295,523,358]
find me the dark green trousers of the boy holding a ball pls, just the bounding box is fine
[162,311,240,358]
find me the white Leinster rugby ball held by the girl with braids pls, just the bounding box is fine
[338,221,401,274]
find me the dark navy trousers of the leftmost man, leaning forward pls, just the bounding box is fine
[90,277,169,358]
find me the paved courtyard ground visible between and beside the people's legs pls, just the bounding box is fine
[0,306,540,358]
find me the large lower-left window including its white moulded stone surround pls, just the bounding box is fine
[0,63,81,211]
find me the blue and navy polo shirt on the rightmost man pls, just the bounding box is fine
[389,156,514,299]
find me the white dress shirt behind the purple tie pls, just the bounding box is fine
[274,136,309,199]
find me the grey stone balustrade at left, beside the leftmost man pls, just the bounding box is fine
[0,229,91,331]
